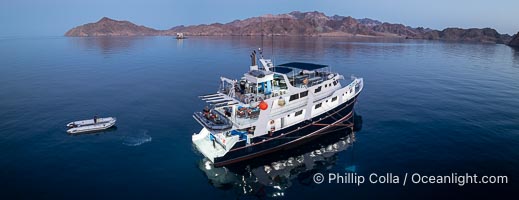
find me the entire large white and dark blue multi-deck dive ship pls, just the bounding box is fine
[192,50,364,167]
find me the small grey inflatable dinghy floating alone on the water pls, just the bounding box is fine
[67,117,117,134]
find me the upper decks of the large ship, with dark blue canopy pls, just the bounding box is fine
[201,49,350,128]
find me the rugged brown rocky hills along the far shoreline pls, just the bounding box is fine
[65,11,519,46]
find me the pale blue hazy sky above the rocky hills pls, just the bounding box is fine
[0,0,519,36]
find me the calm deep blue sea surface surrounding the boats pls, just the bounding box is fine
[0,37,519,199]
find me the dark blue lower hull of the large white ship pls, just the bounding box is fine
[214,94,357,167]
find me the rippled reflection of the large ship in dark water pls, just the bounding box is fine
[199,115,362,197]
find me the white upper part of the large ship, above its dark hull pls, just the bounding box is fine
[192,48,363,162]
